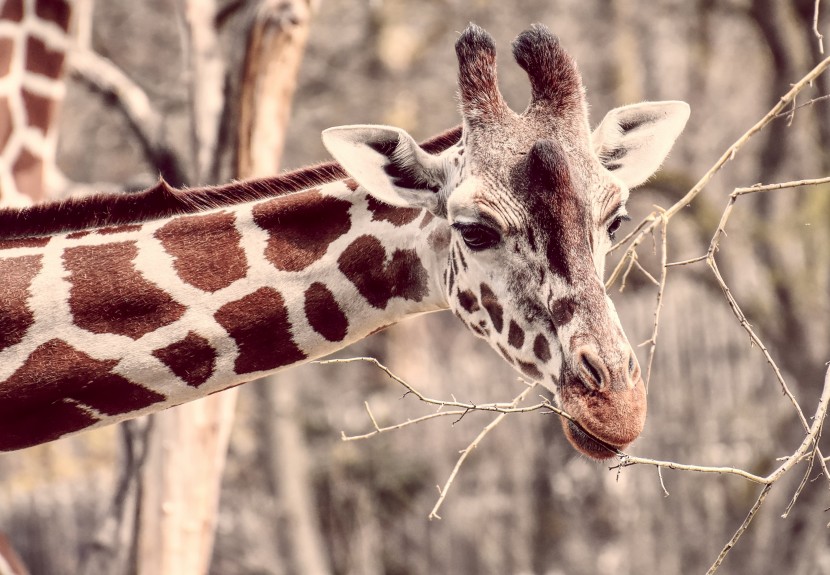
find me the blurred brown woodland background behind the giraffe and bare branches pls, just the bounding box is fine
[0,0,830,575]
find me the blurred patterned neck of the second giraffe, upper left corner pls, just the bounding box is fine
[0,0,72,206]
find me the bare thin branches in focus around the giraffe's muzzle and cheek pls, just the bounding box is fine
[330,50,830,575]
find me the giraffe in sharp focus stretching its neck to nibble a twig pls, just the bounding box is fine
[0,24,689,459]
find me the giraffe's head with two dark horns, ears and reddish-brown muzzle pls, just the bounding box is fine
[323,25,689,459]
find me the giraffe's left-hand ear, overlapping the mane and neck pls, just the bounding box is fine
[323,125,446,213]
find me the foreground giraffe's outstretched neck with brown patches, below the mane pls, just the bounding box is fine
[0,176,449,450]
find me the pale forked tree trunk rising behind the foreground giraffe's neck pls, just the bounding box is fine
[137,0,324,575]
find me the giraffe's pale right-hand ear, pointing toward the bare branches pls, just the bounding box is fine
[591,102,689,188]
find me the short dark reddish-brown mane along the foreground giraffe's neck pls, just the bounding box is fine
[0,126,461,240]
